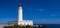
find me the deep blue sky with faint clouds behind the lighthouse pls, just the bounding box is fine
[0,0,60,24]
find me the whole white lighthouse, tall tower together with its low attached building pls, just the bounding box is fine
[18,4,33,25]
